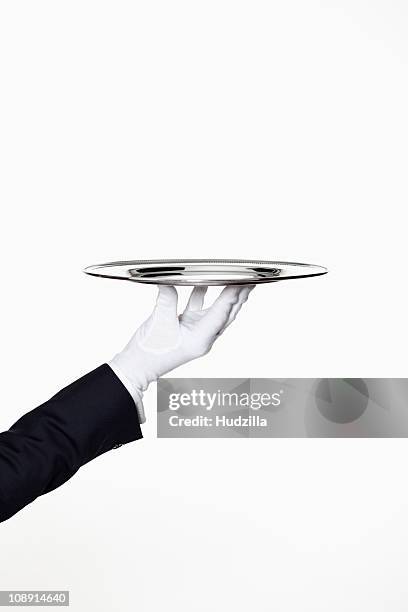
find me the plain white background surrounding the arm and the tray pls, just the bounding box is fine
[0,0,408,612]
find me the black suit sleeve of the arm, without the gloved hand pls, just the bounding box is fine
[0,364,142,521]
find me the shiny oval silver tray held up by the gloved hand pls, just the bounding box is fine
[84,259,327,285]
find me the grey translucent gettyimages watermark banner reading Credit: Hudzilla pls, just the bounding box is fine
[157,378,408,438]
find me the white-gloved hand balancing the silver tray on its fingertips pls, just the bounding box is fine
[108,285,254,423]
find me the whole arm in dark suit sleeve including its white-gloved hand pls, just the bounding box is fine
[0,285,253,522]
